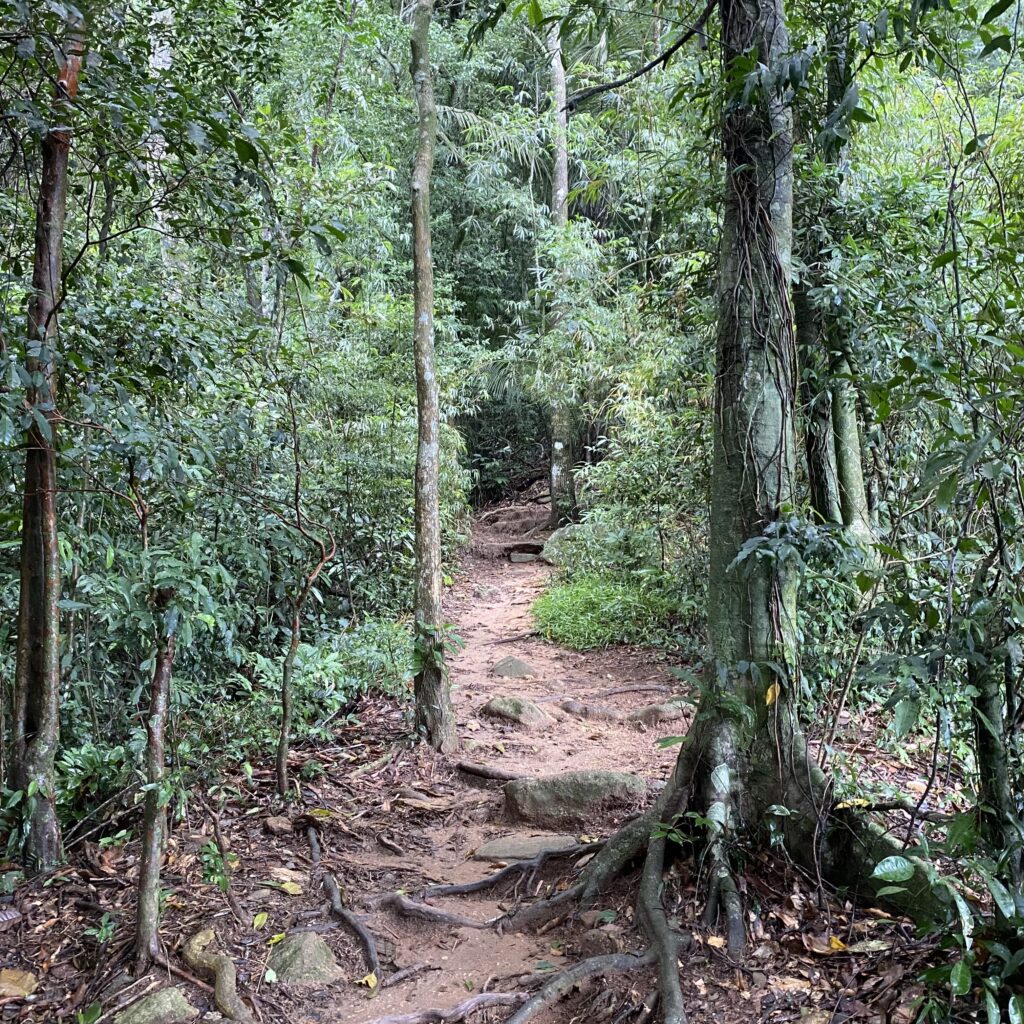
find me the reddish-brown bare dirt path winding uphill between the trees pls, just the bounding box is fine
[331,505,685,1024]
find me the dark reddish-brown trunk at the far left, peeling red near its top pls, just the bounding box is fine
[11,26,83,873]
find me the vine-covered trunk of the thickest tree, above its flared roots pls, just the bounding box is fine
[709,0,797,712]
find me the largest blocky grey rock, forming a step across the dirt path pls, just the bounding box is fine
[505,771,647,826]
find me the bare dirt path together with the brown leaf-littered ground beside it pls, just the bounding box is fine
[0,506,950,1024]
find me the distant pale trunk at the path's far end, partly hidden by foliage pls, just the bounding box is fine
[548,25,575,526]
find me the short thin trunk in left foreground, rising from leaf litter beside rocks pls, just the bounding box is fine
[135,595,175,976]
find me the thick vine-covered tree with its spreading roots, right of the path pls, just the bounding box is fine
[376,0,934,1024]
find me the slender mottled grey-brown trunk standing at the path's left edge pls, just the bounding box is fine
[412,0,459,752]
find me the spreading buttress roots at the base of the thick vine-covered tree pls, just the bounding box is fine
[356,698,928,1024]
